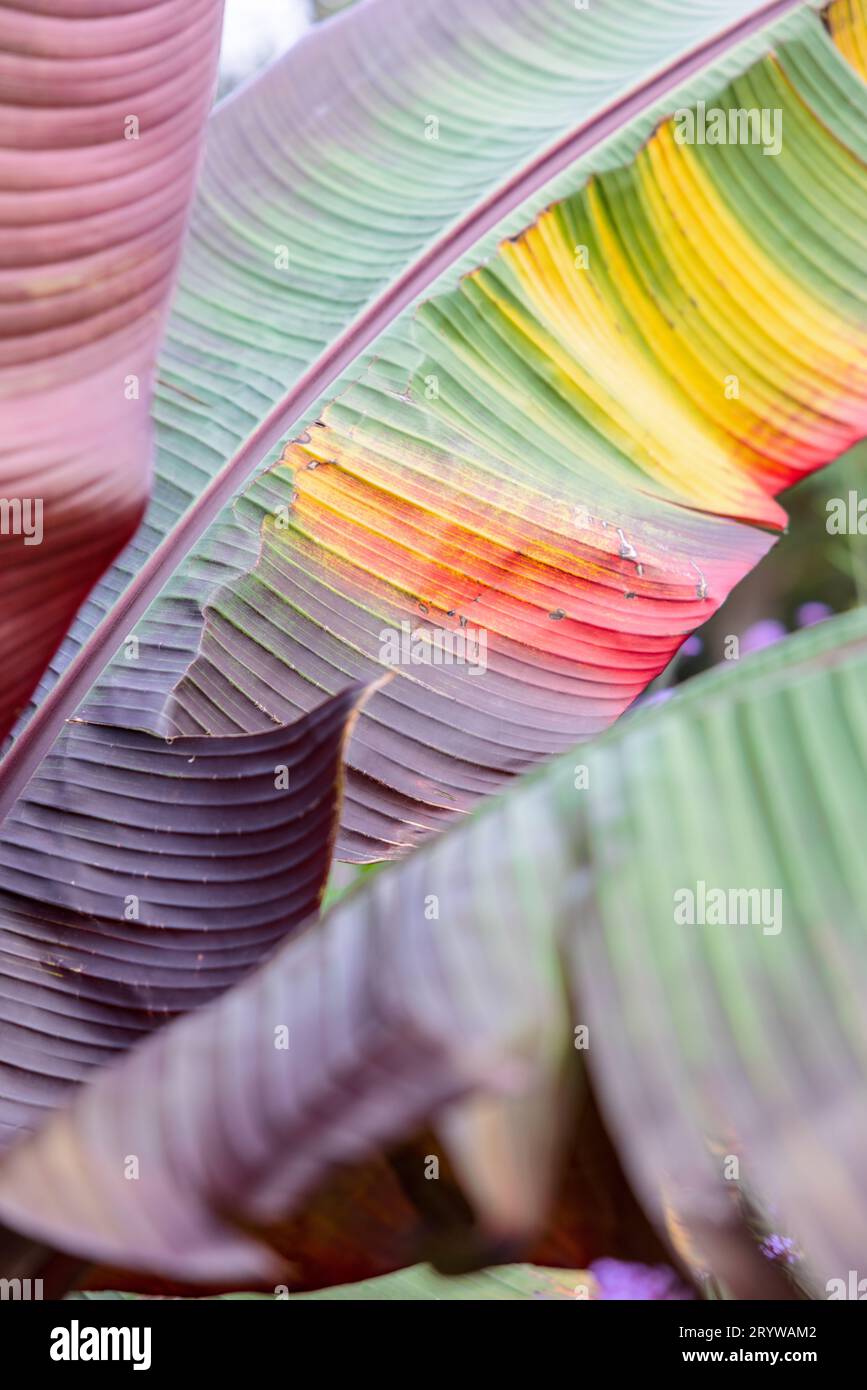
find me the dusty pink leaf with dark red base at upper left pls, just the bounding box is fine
[0,0,222,737]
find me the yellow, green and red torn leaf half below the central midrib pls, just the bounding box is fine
[152,38,867,860]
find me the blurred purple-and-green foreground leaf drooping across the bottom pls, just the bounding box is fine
[0,610,867,1297]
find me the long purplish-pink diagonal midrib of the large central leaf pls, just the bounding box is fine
[0,0,804,821]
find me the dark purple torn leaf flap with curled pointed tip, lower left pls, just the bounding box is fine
[0,688,369,1150]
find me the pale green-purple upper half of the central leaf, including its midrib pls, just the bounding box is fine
[0,0,864,817]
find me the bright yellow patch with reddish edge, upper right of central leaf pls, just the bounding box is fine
[494,67,867,525]
